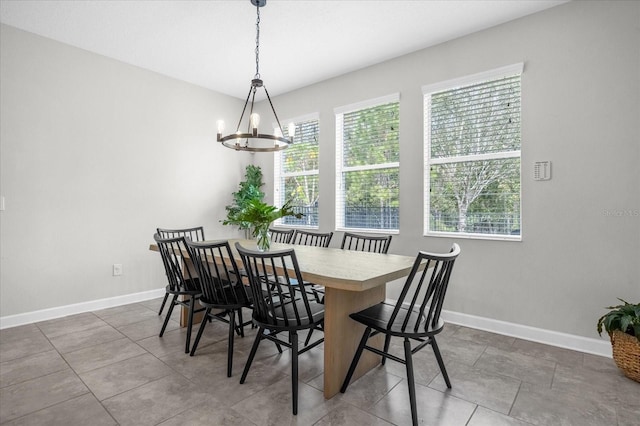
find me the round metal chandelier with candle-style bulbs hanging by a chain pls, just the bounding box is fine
[218,0,295,152]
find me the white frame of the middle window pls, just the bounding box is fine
[334,93,400,234]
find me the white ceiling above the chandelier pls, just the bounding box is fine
[0,0,567,100]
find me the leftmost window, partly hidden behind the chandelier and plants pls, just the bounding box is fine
[273,114,319,227]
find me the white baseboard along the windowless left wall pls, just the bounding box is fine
[0,287,165,330]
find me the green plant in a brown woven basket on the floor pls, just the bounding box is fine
[598,299,640,382]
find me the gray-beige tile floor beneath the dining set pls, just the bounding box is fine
[0,299,640,426]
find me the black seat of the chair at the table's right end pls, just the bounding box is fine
[349,302,444,337]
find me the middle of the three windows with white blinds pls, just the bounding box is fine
[335,94,400,231]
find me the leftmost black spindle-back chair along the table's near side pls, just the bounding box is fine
[153,234,204,353]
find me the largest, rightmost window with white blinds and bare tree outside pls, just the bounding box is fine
[422,64,523,240]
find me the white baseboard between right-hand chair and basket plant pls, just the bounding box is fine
[442,310,612,358]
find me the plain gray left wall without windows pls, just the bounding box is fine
[0,25,251,317]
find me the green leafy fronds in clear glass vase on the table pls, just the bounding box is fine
[222,199,303,251]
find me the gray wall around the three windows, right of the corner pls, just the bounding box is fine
[256,1,640,337]
